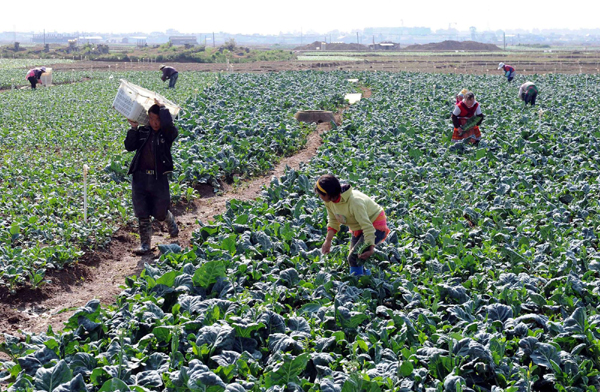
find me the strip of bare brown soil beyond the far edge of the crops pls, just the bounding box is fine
[44,51,600,76]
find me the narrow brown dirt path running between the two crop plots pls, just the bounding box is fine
[0,112,341,346]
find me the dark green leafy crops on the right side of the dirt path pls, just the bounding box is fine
[0,72,600,392]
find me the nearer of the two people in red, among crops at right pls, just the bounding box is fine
[451,91,483,144]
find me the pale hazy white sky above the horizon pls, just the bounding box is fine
[0,0,600,34]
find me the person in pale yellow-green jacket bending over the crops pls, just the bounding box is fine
[315,174,390,276]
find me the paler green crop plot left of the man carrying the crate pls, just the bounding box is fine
[0,73,216,289]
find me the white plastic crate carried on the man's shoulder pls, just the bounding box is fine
[113,79,181,125]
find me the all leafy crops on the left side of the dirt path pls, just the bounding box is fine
[0,72,354,290]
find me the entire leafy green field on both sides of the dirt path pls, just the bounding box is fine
[0,71,600,392]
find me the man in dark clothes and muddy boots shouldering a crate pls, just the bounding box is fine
[125,99,179,255]
